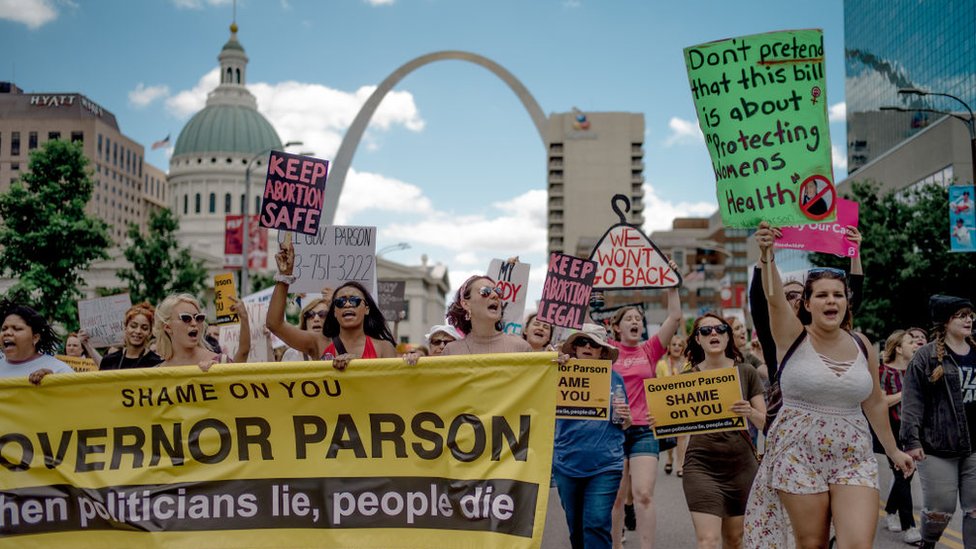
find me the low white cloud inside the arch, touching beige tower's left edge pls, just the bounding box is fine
[380,190,546,254]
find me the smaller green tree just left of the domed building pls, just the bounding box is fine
[118,208,207,305]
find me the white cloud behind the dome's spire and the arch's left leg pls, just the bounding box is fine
[166,68,424,158]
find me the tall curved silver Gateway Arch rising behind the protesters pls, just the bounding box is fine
[321,51,548,225]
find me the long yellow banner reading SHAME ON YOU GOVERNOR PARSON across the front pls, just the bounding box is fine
[0,353,557,549]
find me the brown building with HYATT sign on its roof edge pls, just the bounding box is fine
[0,82,166,243]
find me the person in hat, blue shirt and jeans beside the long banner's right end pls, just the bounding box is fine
[552,323,630,549]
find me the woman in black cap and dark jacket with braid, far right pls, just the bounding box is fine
[901,295,976,548]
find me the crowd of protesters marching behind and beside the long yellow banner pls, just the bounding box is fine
[0,223,976,549]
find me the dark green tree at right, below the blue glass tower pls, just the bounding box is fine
[811,182,976,340]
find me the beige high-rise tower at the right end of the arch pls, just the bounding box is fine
[546,110,644,257]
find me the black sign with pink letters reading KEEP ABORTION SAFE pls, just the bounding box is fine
[261,151,329,235]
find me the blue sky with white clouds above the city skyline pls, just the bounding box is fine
[0,0,846,308]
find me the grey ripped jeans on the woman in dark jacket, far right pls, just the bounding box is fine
[918,454,976,548]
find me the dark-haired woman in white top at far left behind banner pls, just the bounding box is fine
[0,300,74,385]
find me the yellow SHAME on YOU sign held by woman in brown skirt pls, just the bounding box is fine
[644,368,746,438]
